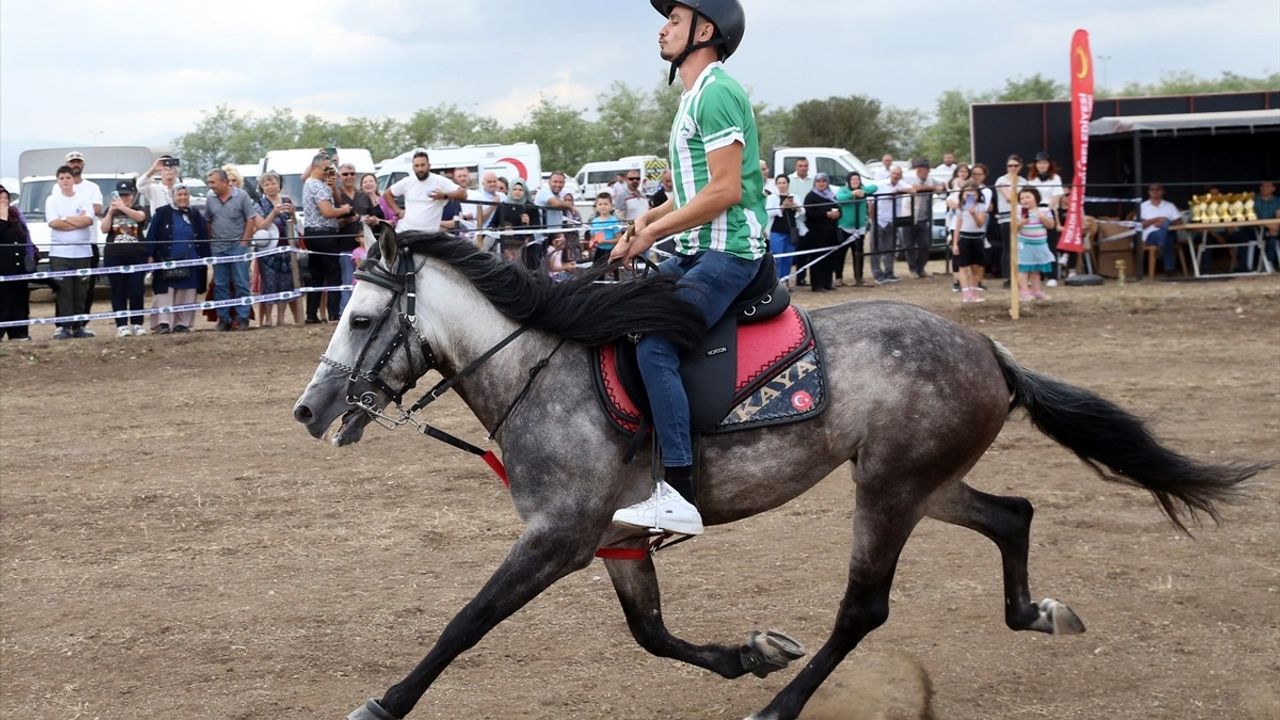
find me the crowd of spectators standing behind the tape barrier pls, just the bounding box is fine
[0,144,1280,340]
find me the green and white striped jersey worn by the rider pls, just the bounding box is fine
[667,63,767,260]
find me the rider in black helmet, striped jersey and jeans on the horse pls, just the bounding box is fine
[612,0,768,534]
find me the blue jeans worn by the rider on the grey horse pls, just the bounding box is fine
[636,250,760,468]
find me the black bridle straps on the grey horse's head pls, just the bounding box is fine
[320,247,436,418]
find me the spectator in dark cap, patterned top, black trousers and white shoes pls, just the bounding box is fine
[100,179,150,337]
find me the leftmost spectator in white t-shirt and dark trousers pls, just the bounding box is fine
[45,165,97,340]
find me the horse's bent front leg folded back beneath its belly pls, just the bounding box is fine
[604,557,804,679]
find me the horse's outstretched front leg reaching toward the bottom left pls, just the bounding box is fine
[348,521,595,720]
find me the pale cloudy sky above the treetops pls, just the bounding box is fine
[0,0,1280,176]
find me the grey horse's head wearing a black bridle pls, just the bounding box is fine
[293,225,435,446]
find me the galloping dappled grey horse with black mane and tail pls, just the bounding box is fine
[293,231,1265,720]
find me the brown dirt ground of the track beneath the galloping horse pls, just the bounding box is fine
[0,265,1280,720]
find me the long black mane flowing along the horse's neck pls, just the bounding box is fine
[399,232,707,347]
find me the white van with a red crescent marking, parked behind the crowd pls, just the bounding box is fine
[378,142,543,192]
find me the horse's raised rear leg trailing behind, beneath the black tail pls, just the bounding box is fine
[925,483,1084,635]
